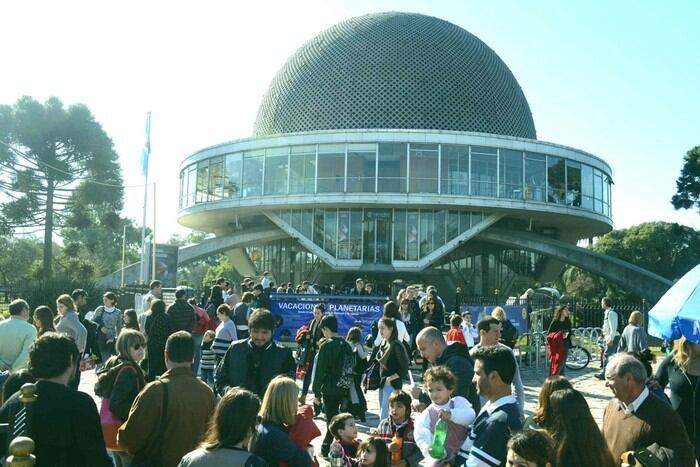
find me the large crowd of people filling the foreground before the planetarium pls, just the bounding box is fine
[0,278,700,467]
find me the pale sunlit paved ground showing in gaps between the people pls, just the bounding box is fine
[80,361,612,465]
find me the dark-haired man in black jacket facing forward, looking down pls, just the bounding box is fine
[214,309,295,398]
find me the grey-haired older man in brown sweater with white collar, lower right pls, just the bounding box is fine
[603,353,695,467]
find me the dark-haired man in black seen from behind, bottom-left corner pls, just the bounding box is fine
[0,332,113,467]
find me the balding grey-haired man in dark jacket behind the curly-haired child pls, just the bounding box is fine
[412,326,481,412]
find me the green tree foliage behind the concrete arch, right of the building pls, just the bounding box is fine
[559,222,700,300]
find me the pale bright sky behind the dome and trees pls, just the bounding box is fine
[0,0,700,242]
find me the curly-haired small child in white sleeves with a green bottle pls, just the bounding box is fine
[414,366,476,466]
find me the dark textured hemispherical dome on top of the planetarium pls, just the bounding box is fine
[254,12,537,139]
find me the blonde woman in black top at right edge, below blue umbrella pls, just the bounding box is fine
[656,337,700,461]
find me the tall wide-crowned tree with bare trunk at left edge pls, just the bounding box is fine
[0,97,124,280]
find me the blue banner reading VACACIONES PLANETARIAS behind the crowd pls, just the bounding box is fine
[270,294,387,342]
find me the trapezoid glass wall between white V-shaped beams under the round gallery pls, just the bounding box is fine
[278,208,488,264]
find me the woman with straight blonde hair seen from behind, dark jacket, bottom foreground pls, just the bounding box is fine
[253,376,320,467]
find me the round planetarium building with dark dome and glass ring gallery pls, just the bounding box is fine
[179,12,612,295]
